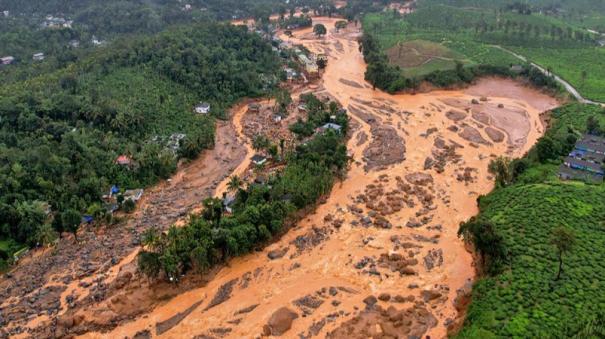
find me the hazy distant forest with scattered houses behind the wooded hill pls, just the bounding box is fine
[0,0,335,65]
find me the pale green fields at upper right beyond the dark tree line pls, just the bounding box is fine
[363,0,605,101]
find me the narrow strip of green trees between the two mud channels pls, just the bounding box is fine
[138,95,349,282]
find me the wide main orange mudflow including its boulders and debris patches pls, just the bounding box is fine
[56,18,558,338]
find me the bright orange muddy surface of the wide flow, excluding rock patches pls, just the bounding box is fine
[78,18,558,338]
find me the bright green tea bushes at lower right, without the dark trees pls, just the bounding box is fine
[457,104,605,339]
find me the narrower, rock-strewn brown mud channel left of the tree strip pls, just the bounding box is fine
[0,111,250,337]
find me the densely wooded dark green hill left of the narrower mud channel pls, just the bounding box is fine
[0,23,280,266]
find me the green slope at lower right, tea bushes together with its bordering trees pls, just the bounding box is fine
[457,104,605,338]
